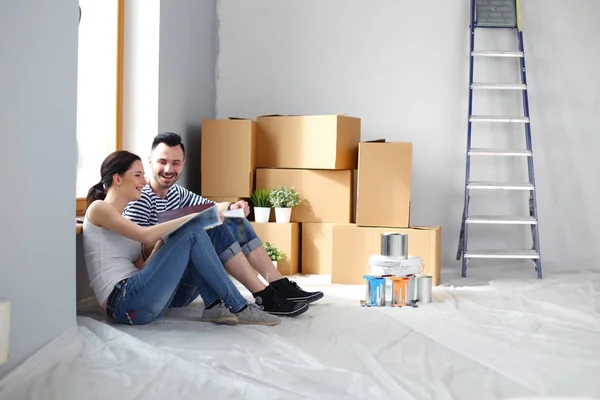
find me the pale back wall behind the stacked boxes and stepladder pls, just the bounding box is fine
[217,0,600,275]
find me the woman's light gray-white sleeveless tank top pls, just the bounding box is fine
[82,216,142,305]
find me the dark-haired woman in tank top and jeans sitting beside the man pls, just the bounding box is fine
[83,151,280,325]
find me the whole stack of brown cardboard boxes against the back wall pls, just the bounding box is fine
[201,115,441,285]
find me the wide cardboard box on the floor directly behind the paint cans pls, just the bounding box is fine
[331,225,442,286]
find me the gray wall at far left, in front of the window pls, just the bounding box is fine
[0,0,78,376]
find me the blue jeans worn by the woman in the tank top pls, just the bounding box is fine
[110,216,247,325]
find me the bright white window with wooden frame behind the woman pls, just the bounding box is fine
[76,0,124,214]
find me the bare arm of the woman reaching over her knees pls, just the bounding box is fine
[87,201,196,243]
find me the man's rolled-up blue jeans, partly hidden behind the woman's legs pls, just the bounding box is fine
[170,218,262,307]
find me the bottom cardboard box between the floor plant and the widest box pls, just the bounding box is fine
[300,222,350,275]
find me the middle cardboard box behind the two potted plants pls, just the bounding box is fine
[256,168,354,223]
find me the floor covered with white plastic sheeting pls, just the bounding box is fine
[0,266,600,400]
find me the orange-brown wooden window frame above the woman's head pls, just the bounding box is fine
[75,0,125,216]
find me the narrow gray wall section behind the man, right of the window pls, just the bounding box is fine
[158,0,217,192]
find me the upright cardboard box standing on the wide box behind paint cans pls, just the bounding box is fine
[356,141,413,228]
